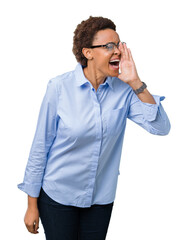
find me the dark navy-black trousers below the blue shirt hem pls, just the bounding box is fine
[38,189,114,240]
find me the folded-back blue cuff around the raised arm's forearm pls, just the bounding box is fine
[139,95,165,122]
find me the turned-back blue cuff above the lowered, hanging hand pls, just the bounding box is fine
[17,183,41,197]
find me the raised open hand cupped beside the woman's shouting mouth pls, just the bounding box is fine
[118,42,141,85]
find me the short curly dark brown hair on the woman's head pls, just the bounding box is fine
[72,16,116,66]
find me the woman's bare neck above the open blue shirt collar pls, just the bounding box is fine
[83,64,106,91]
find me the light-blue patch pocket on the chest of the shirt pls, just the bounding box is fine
[104,107,126,136]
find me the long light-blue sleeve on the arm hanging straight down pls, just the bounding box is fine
[17,80,58,197]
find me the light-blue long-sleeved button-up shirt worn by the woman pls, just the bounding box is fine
[18,64,170,207]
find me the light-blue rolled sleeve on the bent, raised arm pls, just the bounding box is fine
[128,94,171,135]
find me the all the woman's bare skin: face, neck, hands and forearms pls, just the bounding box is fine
[24,29,155,234]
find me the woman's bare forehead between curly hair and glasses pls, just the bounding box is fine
[93,29,120,44]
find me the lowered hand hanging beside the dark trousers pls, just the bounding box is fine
[24,207,39,234]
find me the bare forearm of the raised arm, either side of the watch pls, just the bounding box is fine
[128,79,156,104]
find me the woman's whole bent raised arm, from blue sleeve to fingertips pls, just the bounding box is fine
[118,43,170,135]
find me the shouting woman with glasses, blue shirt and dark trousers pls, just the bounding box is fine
[18,17,170,240]
